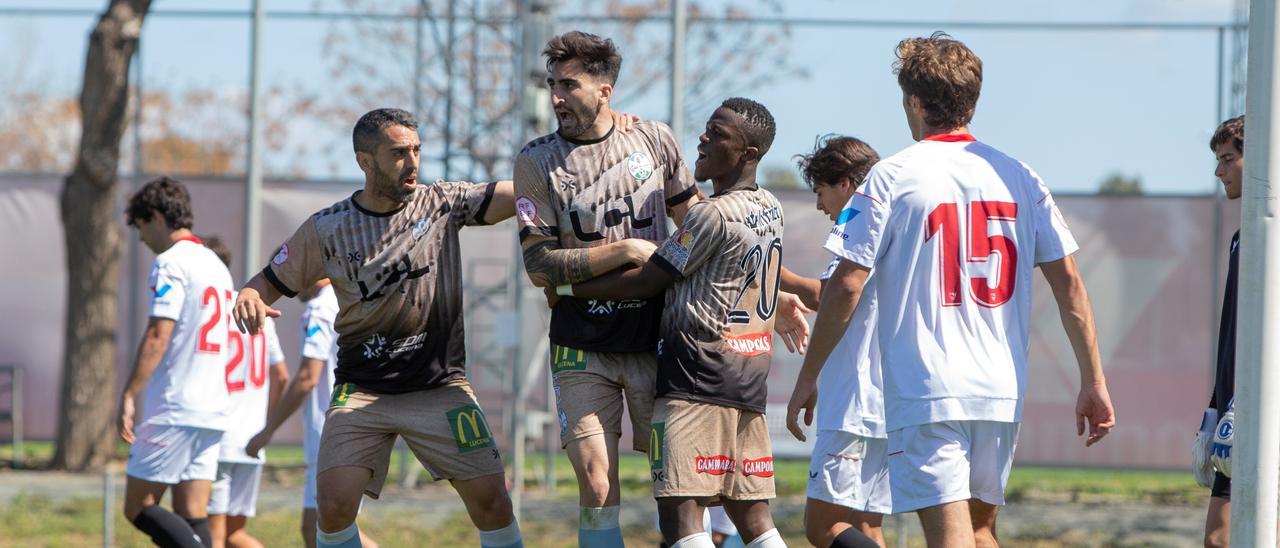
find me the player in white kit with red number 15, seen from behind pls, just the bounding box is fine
[787,33,1115,547]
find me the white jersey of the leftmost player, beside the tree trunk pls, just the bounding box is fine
[138,238,233,430]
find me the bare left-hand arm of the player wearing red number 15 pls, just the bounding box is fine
[787,260,870,442]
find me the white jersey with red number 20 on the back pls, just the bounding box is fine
[218,297,284,462]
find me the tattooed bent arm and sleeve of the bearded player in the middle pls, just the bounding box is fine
[513,155,654,287]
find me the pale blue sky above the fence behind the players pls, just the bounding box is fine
[0,0,1234,193]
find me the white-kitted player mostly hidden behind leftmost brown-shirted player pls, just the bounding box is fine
[244,278,378,548]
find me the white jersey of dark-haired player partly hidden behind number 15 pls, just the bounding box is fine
[817,257,888,438]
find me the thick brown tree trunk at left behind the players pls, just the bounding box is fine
[52,0,151,470]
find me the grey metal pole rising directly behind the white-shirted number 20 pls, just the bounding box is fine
[241,0,266,282]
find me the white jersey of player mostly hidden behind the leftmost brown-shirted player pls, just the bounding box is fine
[302,286,338,463]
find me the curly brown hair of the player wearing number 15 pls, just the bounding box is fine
[893,31,982,131]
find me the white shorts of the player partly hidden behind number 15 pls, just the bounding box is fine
[805,430,893,513]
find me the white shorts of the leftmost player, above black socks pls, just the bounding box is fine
[125,424,223,485]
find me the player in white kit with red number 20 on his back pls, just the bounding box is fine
[204,236,289,548]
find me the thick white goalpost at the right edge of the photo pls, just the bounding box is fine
[1231,0,1280,547]
